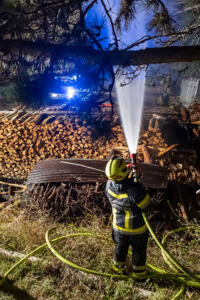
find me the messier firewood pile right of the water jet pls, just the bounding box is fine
[137,119,200,185]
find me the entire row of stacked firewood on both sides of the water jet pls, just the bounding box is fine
[0,106,200,188]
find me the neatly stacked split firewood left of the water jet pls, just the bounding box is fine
[0,112,126,179]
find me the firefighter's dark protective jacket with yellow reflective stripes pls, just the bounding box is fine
[106,178,150,235]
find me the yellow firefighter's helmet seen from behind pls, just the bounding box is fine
[105,156,129,181]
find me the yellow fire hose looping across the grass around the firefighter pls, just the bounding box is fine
[0,213,200,300]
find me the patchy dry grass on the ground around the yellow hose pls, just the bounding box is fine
[0,203,200,300]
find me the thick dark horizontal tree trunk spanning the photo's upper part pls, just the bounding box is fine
[0,40,200,66]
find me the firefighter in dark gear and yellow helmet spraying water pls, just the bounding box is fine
[105,155,151,277]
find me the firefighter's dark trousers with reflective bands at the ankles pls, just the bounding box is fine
[112,230,149,273]
